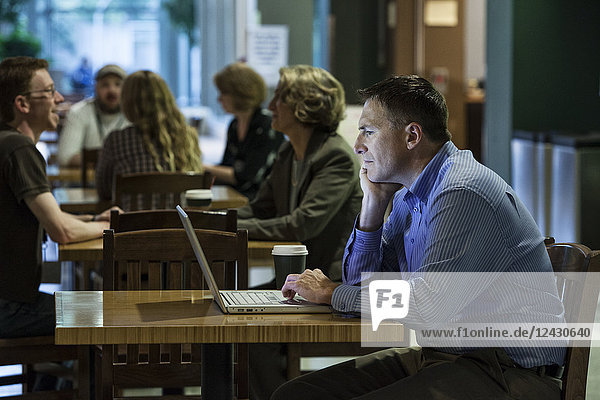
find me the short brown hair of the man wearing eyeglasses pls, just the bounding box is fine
[0,57,48,122]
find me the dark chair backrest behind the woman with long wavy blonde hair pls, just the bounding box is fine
[112,172,213,211]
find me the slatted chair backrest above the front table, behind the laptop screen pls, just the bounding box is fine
[103,229,248,290]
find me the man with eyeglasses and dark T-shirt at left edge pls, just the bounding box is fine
[0,57,116,338]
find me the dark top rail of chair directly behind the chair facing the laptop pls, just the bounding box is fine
[110,210,237,233]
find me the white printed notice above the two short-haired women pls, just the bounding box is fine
[247,25,289,87]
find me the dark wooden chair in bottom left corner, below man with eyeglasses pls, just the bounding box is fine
[0,336,90,400]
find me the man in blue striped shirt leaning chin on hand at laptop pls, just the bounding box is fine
[273,76,565,400]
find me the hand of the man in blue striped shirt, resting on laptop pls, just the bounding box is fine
[281,268,340,304]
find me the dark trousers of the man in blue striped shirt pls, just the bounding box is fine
[271,348,561,400]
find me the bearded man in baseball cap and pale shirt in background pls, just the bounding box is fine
[58,64,129,166]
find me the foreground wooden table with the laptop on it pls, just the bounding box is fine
[55,290,404,400]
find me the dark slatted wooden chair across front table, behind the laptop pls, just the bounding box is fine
[96,229,248,399]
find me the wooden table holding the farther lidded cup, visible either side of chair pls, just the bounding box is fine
[53,185,248,213]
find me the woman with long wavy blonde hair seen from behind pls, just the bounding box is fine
[96,71,202,200]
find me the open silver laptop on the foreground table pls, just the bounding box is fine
[176,206,331,314]
